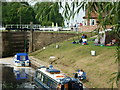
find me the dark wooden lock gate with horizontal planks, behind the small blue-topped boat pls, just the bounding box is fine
[1,32,28,57]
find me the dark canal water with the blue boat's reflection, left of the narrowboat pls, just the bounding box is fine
[2,65,35,90]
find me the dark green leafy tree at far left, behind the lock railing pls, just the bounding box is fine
[2,2,38,25]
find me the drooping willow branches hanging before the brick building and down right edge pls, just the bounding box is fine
[64,0,120,86]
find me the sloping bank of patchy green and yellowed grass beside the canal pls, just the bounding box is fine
[31,37,117,88]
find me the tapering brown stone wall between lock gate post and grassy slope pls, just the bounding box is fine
[33,32,76,51]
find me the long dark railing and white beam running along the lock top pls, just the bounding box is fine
[4,24,70,31]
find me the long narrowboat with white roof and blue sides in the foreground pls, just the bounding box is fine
[34,66,83,90]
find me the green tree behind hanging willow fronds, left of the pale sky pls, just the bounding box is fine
[34,2,64,26]
